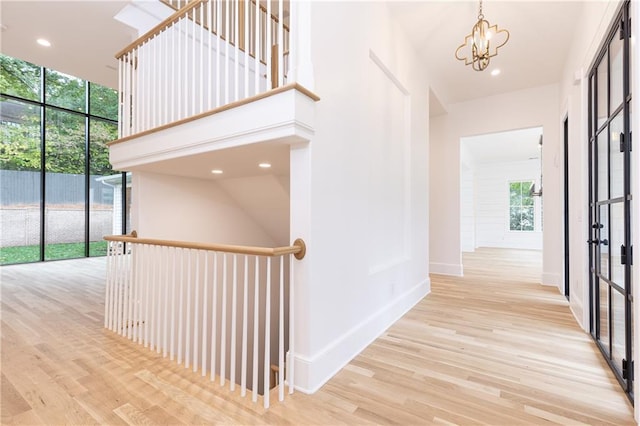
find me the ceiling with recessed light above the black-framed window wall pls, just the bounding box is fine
[0,0,136,88]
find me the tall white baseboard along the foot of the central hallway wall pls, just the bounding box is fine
[294,278,431,394]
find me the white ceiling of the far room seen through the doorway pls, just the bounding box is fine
[460,127,542,168]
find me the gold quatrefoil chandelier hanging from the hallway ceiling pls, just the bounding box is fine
[456,0,509,71]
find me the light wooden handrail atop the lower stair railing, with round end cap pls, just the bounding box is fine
[104,231,307,260]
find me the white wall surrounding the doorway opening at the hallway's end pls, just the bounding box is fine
[429,85,562,286]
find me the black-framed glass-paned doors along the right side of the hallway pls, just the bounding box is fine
[589,1,634,396]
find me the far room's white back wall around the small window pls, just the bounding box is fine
[473,160,542,250]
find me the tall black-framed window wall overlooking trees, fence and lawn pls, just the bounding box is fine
[0,55,129,265]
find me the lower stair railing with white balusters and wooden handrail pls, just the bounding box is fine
[104,231,306,408]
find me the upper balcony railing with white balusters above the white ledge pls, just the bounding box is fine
[116,0,292,138]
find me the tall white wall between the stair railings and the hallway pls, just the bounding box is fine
[291,2,429,392]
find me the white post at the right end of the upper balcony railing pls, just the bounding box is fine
[289,0,314,91]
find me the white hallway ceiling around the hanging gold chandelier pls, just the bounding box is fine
[390,0,585,108]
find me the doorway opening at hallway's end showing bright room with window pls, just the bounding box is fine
[460,127,543,282]
